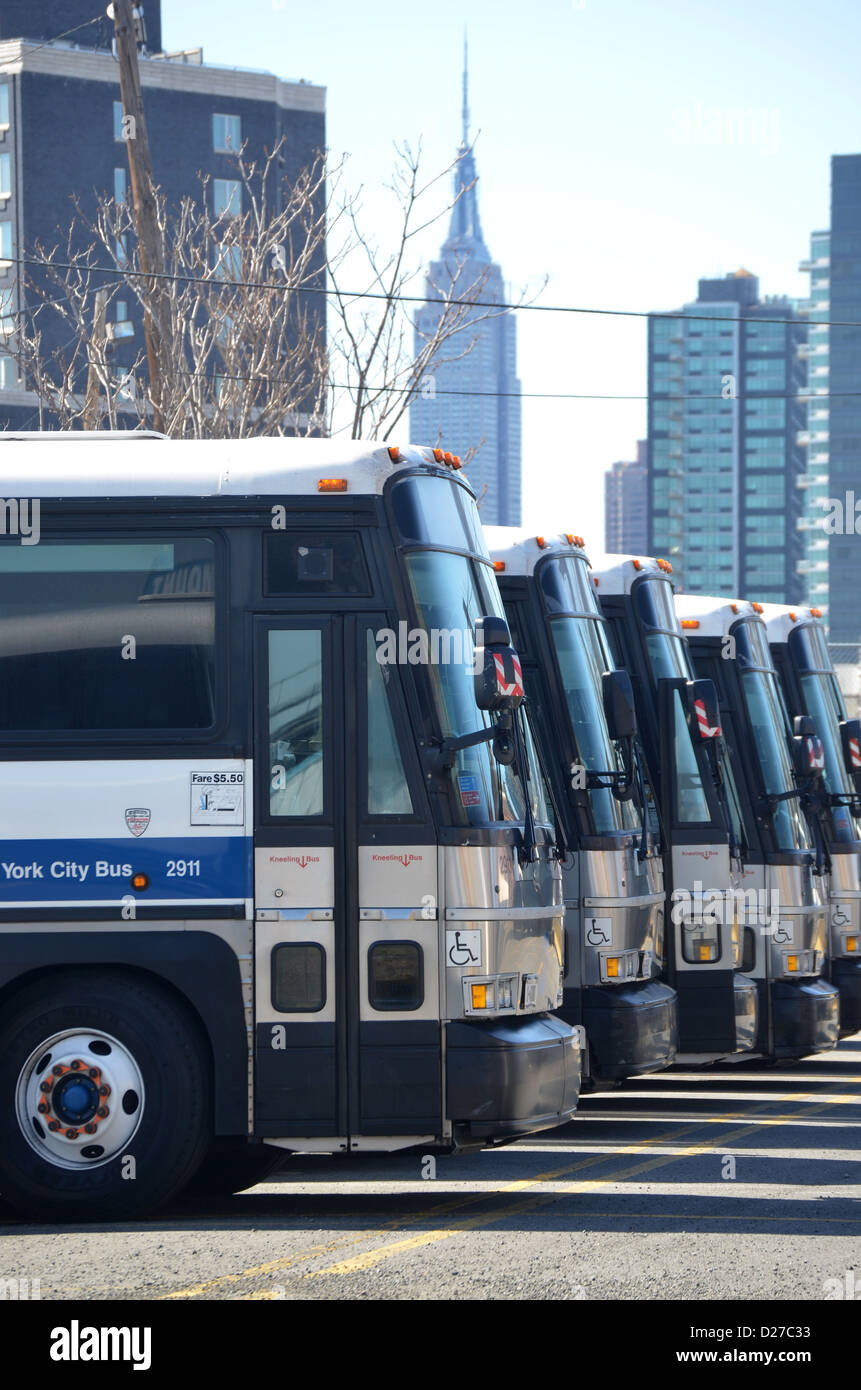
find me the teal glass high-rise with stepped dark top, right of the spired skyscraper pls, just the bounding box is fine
[648,270,805,603]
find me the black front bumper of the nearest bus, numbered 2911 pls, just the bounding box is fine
[445,1013,581,1147]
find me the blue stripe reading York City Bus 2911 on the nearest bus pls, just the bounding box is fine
[0,835,253,905]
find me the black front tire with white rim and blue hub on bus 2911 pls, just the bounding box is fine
[0,969,211,1222]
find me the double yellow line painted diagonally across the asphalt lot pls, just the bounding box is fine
[159,1077,861,1301]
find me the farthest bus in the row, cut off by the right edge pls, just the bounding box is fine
[762,603,861,1036]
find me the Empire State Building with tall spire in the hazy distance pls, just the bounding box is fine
[409,46,520,525]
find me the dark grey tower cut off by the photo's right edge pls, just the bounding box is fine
[825,154,861,653]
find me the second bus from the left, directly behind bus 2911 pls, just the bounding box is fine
[485,527,677,1086]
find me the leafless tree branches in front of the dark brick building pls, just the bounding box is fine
[14,142,337,439]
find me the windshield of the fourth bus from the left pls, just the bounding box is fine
[733,621,811,849]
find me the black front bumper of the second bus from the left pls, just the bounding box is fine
[583,980,679,1081]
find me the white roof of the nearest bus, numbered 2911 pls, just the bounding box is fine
[0,430,467,498]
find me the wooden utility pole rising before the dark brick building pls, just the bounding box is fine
[107,0,170,430]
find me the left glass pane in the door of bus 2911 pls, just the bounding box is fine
[268,628,323,819]
